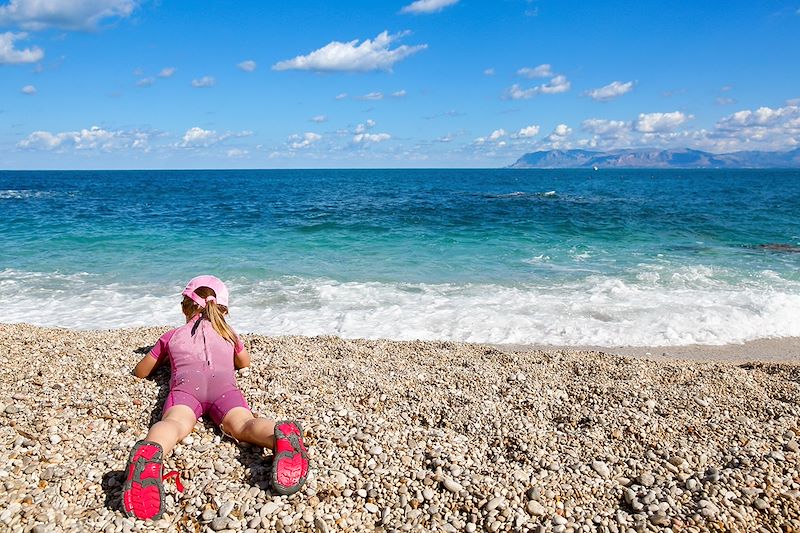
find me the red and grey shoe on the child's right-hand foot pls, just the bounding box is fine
[272,420,308,495]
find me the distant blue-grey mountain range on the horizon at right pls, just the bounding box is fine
[509,148,800,168]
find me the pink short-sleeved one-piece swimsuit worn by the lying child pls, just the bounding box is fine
[150,318,249,425]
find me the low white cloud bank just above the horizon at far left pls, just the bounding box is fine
[17,126,155,152]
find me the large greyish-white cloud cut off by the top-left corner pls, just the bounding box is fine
[0,0,138,31]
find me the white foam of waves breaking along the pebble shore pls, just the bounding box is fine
[0,267,800,346]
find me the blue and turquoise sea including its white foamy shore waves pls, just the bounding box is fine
[0,169,800,346]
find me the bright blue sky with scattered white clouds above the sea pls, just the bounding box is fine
[0,0,800,169]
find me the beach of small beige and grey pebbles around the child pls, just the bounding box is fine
[0,324,800,533]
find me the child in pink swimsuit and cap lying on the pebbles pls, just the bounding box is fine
[123,276,308,520]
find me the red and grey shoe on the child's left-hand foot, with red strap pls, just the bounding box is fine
[122,440,183,520]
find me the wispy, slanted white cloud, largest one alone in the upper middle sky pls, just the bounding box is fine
[272,31,428,72]
